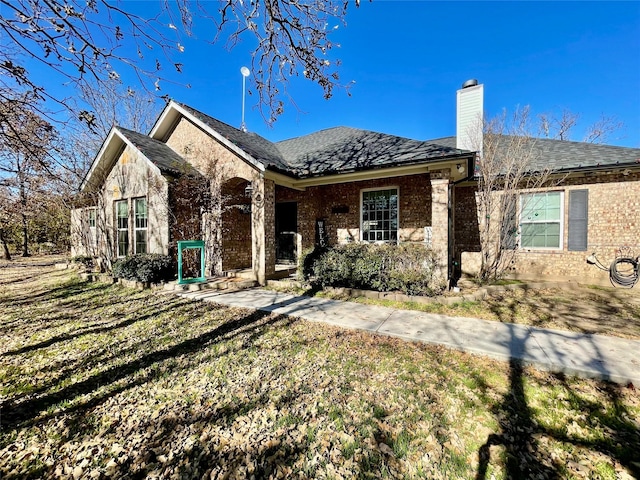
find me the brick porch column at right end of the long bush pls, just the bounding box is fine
[431,173,449,282]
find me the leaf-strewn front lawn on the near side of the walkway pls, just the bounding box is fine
[0,266,640,479]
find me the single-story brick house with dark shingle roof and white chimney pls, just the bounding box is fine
[72,82,640,284]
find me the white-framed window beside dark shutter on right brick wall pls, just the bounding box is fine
[520,192,563,249]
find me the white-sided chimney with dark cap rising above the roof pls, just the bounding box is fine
[456,79,484,154]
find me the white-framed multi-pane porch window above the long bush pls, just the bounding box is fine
[362,188,398,242]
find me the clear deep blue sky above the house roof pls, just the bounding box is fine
[22,0,640,147]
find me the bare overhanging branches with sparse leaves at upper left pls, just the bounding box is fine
[0,0,359,137]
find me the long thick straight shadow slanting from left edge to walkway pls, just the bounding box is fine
[0,311,294,429]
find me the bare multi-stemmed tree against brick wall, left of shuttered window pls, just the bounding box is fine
[474,106,622,282]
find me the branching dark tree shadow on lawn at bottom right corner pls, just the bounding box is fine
[476,328,640,480]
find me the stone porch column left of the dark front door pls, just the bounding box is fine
[251,177,276,285]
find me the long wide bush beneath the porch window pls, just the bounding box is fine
[301,243,442,295]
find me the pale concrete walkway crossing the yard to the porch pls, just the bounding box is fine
[179,288,640,387]
